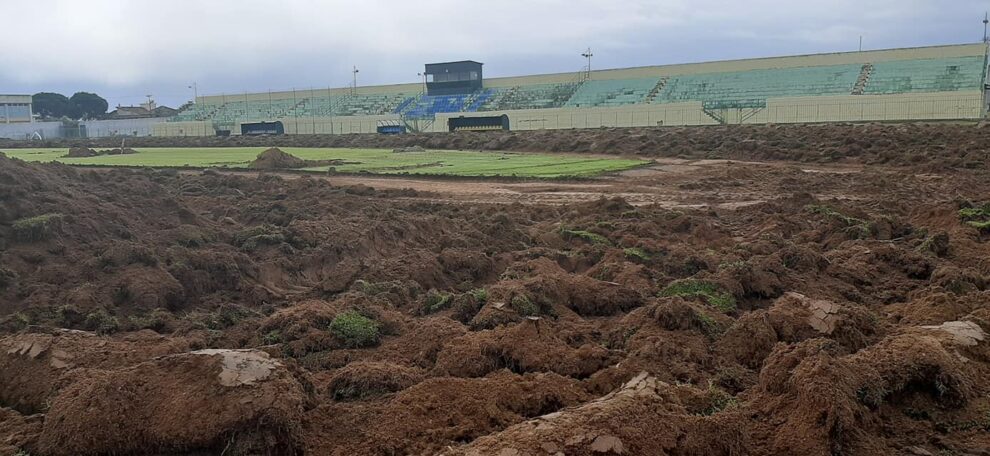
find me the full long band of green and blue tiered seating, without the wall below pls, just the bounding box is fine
[171,55,986,124]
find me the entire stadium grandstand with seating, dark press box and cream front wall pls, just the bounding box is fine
[155,44,987,136]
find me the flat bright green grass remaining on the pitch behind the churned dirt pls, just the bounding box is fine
[3,147,648,178]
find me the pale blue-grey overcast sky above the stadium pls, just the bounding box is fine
[0,0,990,106]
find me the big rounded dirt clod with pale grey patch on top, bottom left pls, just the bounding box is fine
[38,350,306,455]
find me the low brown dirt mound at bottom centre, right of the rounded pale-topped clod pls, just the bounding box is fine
[309,371,588,454]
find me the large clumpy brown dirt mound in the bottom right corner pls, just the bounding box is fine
[758,330,976,454]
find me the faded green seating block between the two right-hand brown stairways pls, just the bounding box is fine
[654,65,862,103]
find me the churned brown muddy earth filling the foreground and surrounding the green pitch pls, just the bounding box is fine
[0,125,990,456]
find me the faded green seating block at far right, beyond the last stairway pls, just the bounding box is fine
[864,56,984,95]
